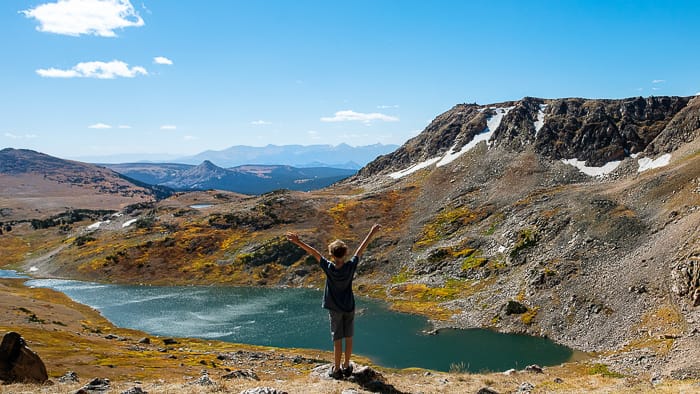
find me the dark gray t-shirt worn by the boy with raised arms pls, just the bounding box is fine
[320,256,360,312]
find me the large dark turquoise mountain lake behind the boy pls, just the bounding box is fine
[15,279,572,372]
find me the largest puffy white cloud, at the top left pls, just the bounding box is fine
[20,0,144,37]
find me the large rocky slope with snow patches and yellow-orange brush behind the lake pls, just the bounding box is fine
[0,97,700,390]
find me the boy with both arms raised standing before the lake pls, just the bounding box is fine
[287,224,381,379]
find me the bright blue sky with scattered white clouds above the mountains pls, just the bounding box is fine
[0,0,700,158]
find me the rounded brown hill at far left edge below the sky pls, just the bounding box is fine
[0,148,170,221]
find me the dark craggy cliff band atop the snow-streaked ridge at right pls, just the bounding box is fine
[359,97,700,176]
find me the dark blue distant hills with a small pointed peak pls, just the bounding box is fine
[106,160,356,194]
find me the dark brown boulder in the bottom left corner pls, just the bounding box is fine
[0,332,49,383]
